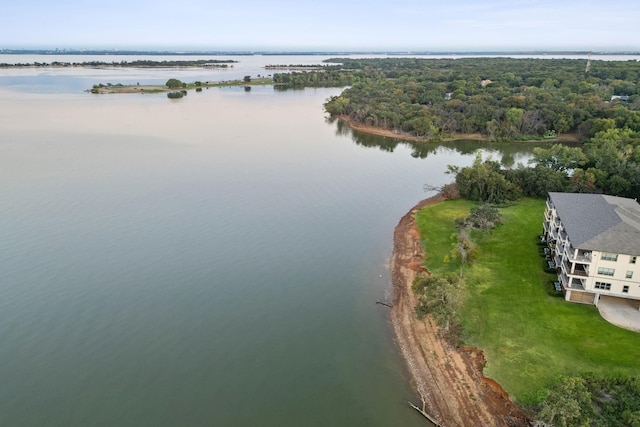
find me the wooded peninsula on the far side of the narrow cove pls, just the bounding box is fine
[316,58,640,140]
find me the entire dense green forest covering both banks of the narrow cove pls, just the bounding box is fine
[274,58,640,202]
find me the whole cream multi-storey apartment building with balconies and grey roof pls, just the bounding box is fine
[543,193,640,305]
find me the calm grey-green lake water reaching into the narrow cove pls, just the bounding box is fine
[0,57,540,426]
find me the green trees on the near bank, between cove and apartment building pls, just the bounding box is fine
[449,128,640,203]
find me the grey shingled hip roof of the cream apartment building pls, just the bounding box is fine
[549,193,640,255]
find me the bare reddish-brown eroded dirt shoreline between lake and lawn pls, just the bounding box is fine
[391,195,529,427]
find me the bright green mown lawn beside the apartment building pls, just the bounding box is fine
[417,199,640,404]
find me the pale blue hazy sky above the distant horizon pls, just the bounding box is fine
[5,0,640,51]
